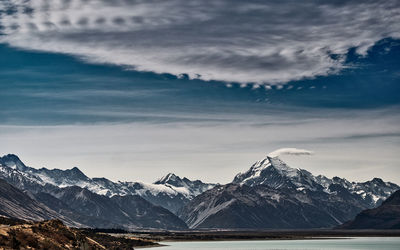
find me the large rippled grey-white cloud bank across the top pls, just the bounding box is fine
[0,0,400,84]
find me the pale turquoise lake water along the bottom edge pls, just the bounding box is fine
[152,237,400,250]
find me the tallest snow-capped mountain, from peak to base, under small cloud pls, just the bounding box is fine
[179,157,399,228]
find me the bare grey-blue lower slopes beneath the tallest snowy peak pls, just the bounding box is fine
[181,184,346,229]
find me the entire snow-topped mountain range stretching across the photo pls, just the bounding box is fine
[0,154,399,230]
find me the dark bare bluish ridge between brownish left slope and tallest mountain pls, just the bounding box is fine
[51,186,186,229]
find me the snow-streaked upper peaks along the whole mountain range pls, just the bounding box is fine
[0,152,399,212]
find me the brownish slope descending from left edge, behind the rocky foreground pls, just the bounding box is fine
[0,179,82,226]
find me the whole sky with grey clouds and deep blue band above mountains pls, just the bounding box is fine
[0,0,400,184]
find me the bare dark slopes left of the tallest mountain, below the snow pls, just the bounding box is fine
[0,175,186,230]
